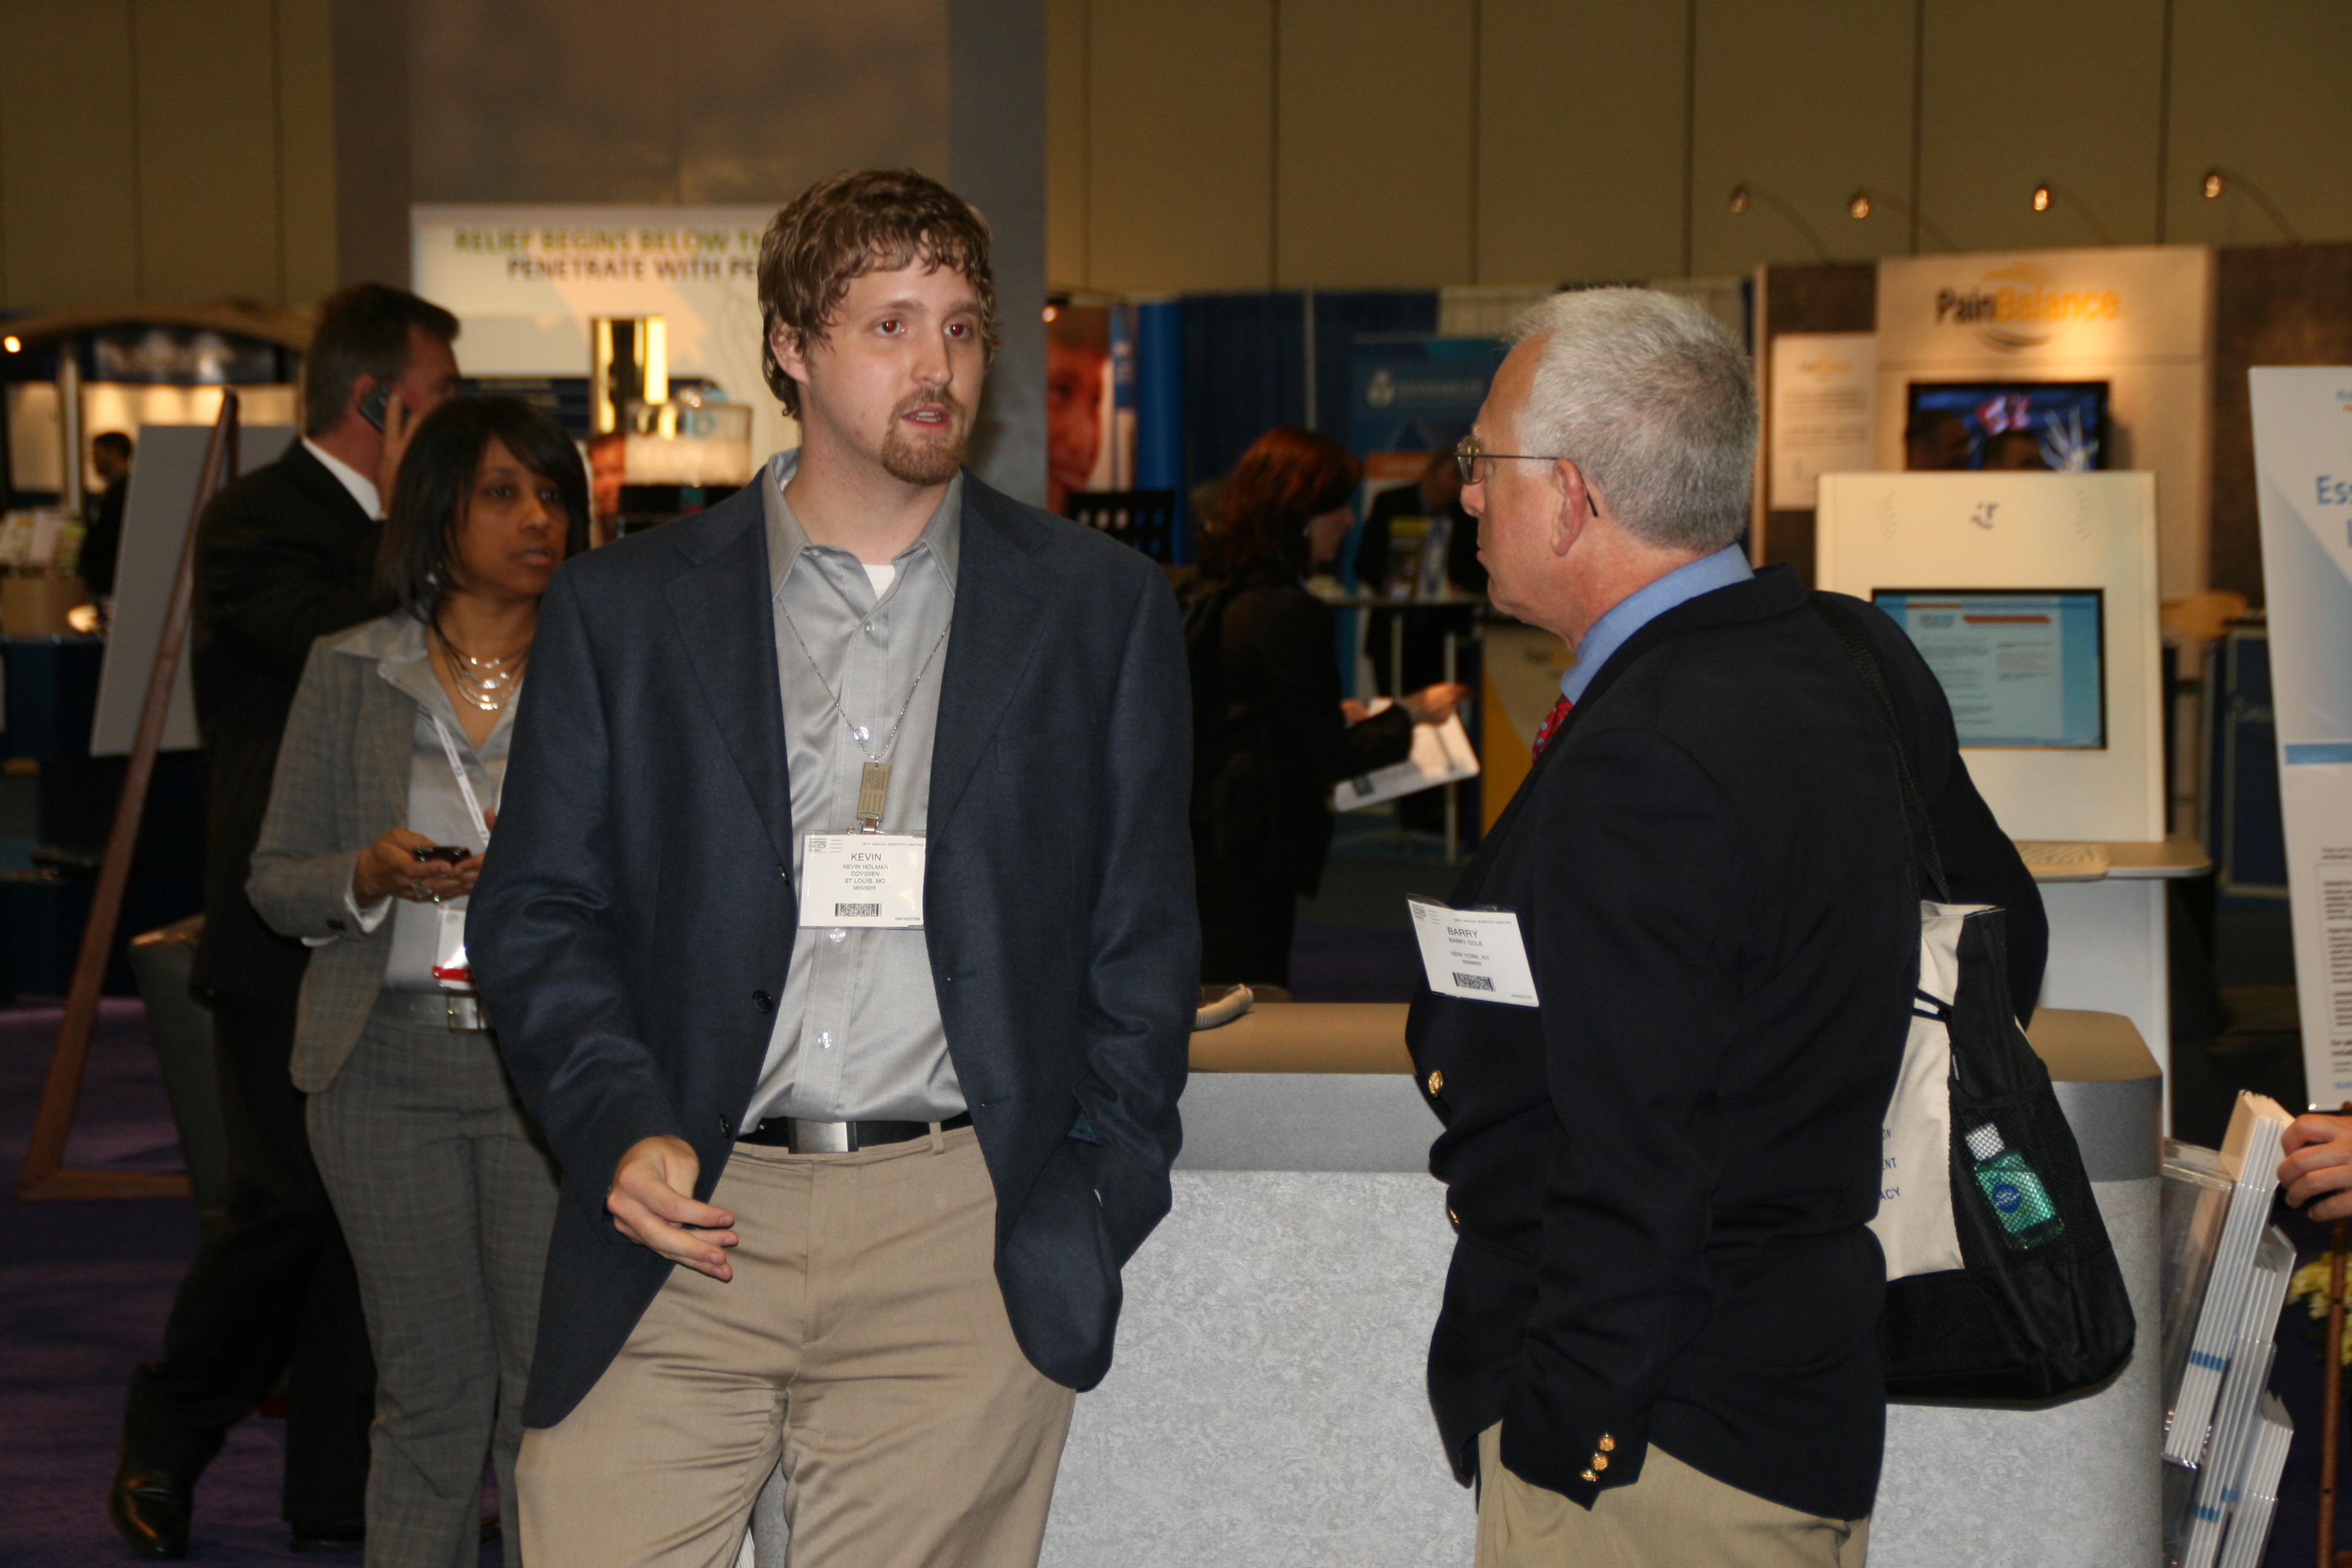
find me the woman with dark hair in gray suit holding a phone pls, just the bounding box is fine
[247,397,588,1568]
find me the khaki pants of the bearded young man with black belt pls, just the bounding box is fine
[517,1128,1073,1568]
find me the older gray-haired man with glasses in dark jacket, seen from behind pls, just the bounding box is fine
[1409,289,2047,1568]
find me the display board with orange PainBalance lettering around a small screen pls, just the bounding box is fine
[1875,244,2213,595]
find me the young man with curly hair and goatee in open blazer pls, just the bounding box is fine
[468,169,1200,1568]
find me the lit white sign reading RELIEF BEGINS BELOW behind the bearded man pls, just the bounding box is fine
[410,202,800,461]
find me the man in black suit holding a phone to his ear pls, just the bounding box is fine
[106,282,459,1557]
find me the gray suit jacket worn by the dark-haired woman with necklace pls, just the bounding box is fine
[244,611,416,1093]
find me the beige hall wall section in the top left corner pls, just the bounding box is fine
[0,0,334,310]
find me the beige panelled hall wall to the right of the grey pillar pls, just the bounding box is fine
[1047,0,2352,292]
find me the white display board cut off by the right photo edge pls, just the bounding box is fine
[2251,367,2352,1107]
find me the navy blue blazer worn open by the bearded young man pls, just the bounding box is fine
[466,475,1200,1427]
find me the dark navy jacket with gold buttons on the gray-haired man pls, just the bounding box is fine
[1409,567,2048,1518]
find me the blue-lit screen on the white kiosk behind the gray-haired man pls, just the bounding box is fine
[1870,588,2108,753]
